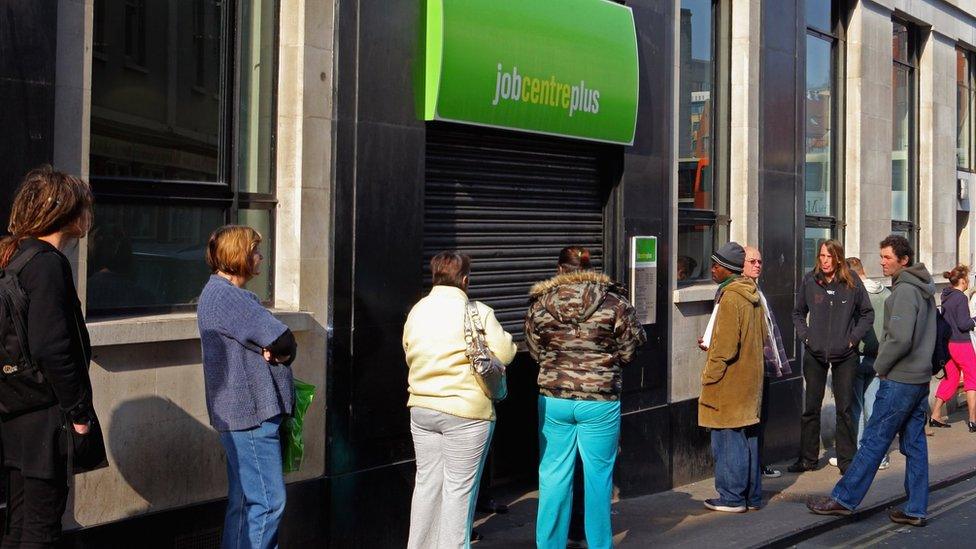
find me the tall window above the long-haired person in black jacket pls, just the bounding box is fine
[803,0,845,270]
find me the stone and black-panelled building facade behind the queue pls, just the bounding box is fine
[0,0,976,547]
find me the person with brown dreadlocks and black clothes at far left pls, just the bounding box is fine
[0,167,105,549]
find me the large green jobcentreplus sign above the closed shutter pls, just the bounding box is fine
[424,0,638,145]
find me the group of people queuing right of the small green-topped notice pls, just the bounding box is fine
[698,235,940,526]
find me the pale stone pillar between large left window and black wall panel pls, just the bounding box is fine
[275,0,335,316]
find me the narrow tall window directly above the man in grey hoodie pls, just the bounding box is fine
[891,20,918,246]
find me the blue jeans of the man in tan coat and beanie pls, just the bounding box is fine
[712,425,762,507]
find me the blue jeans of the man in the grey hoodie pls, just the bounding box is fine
[831,379,929,517]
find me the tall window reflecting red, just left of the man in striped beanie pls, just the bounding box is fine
[676,0,731,285]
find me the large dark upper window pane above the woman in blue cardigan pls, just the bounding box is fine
[90,0,224,186]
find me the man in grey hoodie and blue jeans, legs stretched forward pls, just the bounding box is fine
[807,235,936,526]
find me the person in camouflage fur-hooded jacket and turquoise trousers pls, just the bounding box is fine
[525,247,646,549]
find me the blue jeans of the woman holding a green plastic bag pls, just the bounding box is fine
[220,416,285,549]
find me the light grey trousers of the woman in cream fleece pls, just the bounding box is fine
[407,406,495,549]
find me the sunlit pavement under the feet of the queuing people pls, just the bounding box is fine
[475,409,976,549]
